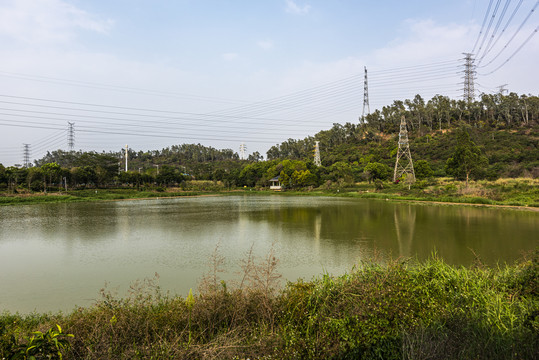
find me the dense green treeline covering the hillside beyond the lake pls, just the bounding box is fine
[0,93,539,191]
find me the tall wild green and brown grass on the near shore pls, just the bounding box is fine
[0,251,539,359]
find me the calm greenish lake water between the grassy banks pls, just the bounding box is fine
[0,196,539,313]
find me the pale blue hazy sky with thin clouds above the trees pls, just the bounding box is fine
[0,0,539,166]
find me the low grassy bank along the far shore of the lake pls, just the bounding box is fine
[0,178,539,208]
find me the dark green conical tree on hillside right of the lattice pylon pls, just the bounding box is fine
[445,128,488,187]
